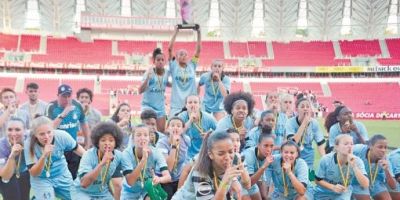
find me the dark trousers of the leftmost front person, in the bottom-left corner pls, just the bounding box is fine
[0,171,31,200]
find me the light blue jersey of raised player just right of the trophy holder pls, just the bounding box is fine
[199,72,231,114]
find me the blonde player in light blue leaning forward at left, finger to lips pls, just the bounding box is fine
[24,116,85,199]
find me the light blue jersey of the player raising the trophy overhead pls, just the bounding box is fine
[169,58,197,116]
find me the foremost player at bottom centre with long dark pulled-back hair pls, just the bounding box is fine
[172,131,250,200]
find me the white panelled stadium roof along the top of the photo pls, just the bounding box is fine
[0,0,399,41]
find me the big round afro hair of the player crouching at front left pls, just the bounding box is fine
[91,122,123,149]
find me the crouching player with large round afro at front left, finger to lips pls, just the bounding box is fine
[71,122,127,200]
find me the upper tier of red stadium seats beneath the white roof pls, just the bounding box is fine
[0,33,400,67]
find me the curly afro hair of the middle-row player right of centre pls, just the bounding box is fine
[224,91,255,116]
